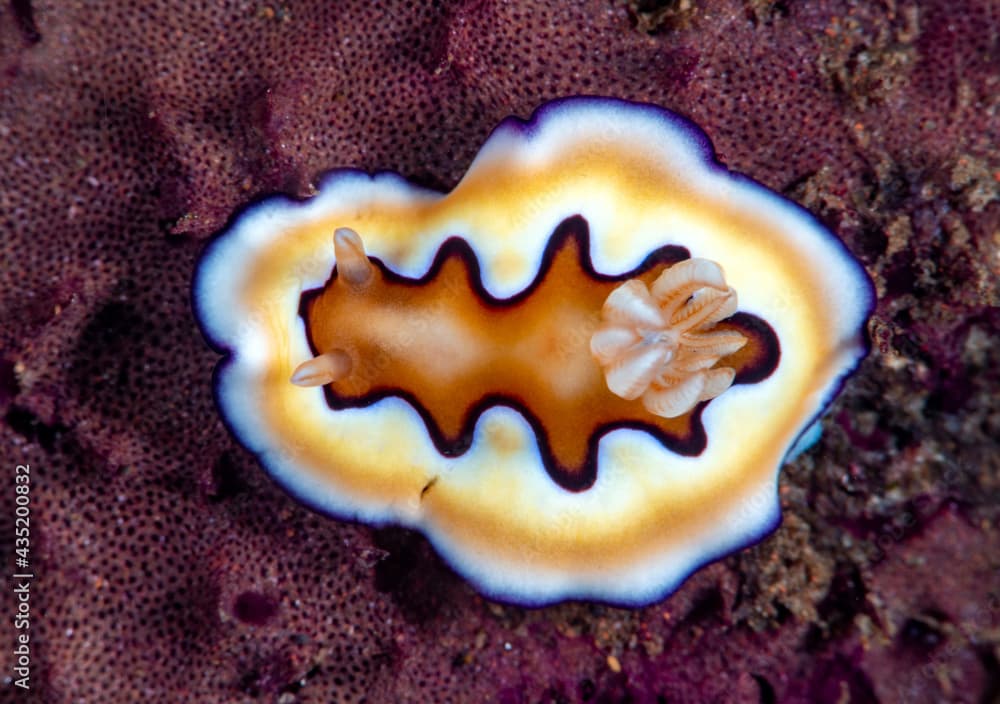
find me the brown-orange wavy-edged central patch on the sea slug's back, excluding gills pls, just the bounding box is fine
[302,216,779,490]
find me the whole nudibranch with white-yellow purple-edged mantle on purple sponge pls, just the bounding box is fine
[194,98,873,604]
